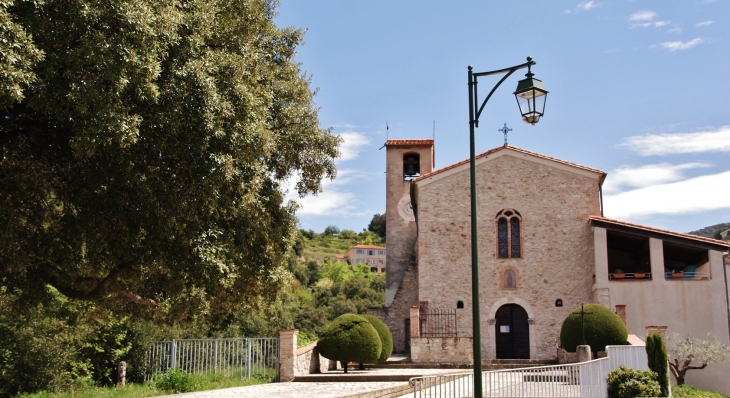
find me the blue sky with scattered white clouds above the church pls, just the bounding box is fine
[276,0,730,232]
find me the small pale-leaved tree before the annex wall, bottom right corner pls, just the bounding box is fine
[669,333,730,386]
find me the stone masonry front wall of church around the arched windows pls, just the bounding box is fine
[417,149,600,359]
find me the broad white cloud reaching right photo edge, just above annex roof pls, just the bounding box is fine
[604,171,730,221]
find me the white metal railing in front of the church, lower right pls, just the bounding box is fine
[410,346,648,398]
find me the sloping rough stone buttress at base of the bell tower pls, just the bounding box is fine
[368,264,418,352]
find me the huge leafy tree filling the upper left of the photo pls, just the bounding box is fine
[0,0,340,321]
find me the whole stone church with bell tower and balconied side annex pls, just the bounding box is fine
[371,139,730,392]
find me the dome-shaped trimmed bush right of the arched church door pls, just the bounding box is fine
[560,304,629,352]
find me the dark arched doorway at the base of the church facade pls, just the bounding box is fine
[494,304,530,359]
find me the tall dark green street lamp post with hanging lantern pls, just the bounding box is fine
[468,57,548,397]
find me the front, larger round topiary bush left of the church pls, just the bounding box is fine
[317,314,383,373]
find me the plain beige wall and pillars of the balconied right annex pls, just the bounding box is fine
[593,232,730,394]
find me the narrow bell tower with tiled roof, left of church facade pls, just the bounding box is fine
[385,139,434,307]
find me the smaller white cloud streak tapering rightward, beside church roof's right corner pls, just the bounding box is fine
[603,162,710,195]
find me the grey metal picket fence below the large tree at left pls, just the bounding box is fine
[146,338,279,381]
